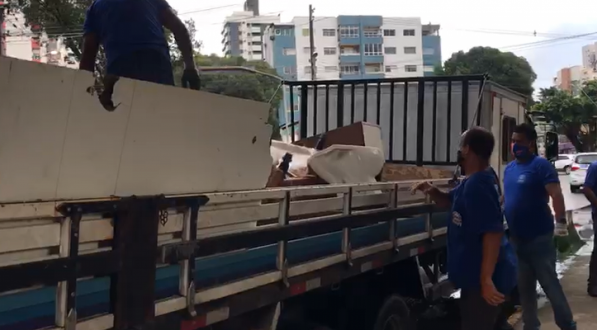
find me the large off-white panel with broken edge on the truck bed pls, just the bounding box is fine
[0,58,271,202]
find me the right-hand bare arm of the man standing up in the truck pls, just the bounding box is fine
[155,0,195,69]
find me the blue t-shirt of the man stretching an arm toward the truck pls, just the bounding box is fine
[448,171,516,294]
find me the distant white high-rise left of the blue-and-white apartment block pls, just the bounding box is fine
[222,11,280,61]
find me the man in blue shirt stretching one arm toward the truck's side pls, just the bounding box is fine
[413,127,516,330]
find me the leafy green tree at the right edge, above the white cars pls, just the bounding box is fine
[532,81,597,151]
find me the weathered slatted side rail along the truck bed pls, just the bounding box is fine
[0,180,447,329]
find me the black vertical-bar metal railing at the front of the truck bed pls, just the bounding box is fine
[284,75,487,166]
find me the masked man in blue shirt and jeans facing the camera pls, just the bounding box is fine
[504,124,576,330]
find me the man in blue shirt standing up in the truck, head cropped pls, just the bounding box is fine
[79,0,199,107]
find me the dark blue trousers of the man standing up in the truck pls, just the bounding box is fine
[106,49,174,85]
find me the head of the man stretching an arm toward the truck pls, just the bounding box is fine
[458,127,495,167]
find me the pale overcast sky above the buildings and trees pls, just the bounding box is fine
[169,0,597,88]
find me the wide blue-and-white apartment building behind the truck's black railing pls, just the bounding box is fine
[264,16,441,80]
